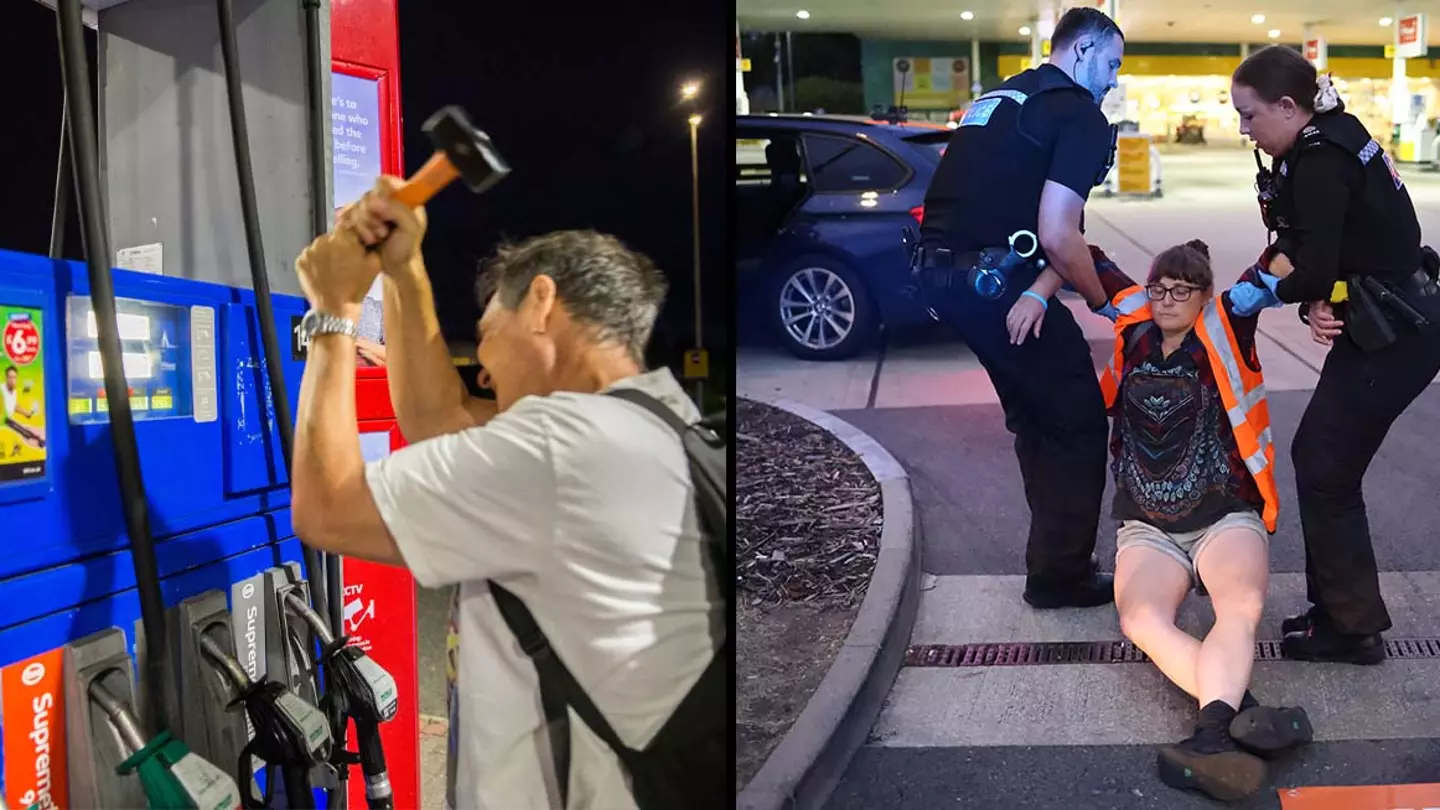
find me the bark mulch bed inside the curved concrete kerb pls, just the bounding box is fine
[734,399,883,790]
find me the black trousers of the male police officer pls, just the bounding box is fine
[926,277,1109,588]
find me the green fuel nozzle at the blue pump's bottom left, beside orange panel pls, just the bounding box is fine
[89,680,240,810]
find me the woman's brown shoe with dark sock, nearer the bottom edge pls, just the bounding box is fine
[1156,700,1267,801]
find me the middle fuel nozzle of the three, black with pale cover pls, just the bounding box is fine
[200,636,331,810]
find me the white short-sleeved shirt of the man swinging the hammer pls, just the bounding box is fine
[366,370,724,810]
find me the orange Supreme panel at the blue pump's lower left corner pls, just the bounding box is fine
[0,649,69,810]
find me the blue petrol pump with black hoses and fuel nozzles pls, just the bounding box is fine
[0,0,408,810]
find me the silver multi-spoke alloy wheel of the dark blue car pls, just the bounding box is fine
[766,257,880,360]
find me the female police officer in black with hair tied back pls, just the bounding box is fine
[1230,46,1440,663]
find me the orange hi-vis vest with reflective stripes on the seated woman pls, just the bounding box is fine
[1100,285,1280,533]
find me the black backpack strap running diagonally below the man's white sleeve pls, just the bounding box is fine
[490,581,634,807]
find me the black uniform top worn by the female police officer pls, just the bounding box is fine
[1276,116,1420,304]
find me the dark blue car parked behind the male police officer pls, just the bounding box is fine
[733,115,950,360]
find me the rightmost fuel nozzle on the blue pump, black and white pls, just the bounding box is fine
[285,592,400,810]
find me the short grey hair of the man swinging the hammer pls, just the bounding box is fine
[478,231,670,365]
